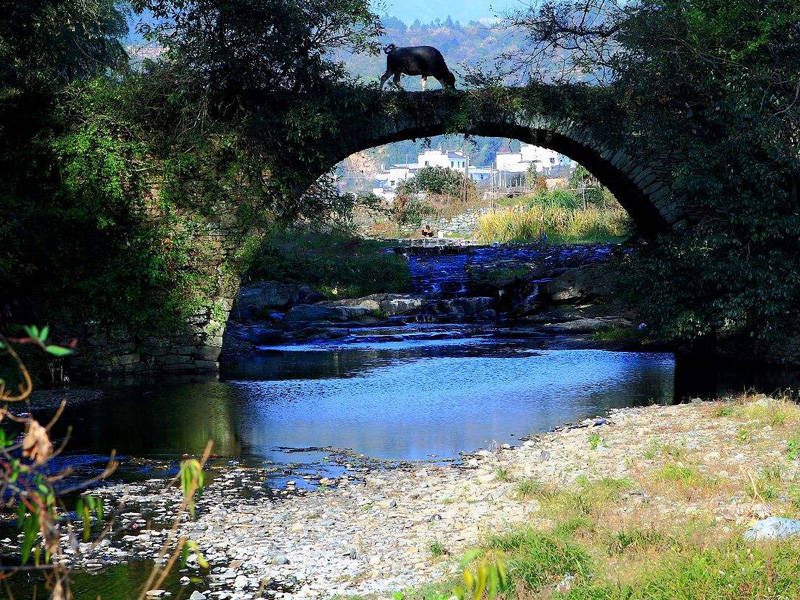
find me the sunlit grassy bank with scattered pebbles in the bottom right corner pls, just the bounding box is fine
[398,396,800,600]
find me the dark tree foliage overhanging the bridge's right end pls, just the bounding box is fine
[511,0,800,349]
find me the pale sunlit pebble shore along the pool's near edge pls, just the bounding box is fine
[34,397,800,600]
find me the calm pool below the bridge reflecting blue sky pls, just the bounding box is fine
[57,342,674,462]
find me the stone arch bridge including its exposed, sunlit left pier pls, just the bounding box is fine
[76,86,690,374]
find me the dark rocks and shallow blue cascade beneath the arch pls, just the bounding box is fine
[221,245,653,365]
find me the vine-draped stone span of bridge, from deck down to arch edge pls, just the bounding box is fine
[296,87,689,235]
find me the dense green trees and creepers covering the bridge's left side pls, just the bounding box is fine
[0,0,386,338]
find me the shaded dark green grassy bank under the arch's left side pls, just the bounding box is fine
[246,231,411,299]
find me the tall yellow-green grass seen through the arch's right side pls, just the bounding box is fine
[477,204,630,243]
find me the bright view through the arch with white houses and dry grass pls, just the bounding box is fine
[334,130,651,242]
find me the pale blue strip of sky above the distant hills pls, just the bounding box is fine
[373,0,523,25]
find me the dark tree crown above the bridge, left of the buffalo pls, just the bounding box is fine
[133,0,382,100]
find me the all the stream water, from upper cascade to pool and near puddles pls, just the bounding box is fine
[14,248,798,600]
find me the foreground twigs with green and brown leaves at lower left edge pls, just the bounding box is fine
[0,326,211,600]
